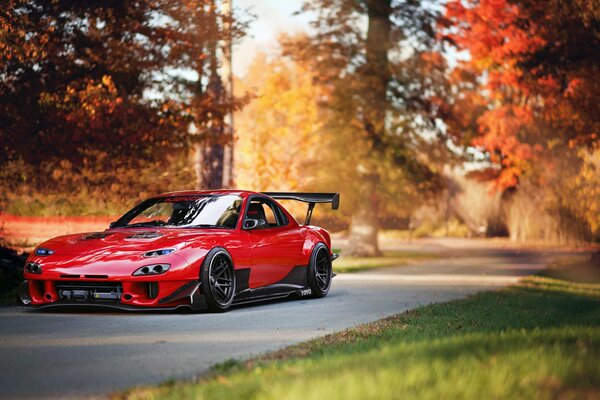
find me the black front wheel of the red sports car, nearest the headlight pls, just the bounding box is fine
[200,247,235,312]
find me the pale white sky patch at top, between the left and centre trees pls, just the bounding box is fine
[232,0,309,77]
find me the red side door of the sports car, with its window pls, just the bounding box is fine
[244,196,304,289]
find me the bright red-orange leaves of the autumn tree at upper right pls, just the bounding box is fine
[445,0,584,188]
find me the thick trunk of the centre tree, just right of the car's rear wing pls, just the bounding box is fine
[347,0,392,257]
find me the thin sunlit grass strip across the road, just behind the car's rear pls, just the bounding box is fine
[333,249,439,272]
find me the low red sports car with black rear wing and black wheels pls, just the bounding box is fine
[18,190,339,311]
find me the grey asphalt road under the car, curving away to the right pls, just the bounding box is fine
[0,248,552,398]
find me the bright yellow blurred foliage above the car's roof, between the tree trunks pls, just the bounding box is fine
[235,52,321,190]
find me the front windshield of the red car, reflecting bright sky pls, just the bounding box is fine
[114,195,242,229]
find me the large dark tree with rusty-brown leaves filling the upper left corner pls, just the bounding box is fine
[0,0,245,198]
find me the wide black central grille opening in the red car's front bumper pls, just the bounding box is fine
[55,281,123,303]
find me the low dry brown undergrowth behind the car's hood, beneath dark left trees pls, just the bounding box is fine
[0,154,195,216]
